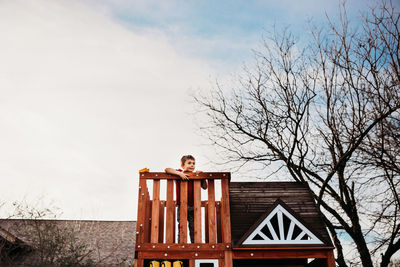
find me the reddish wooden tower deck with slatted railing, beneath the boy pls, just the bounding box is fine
[135,172,232,266]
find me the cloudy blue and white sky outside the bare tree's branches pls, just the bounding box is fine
[0,0,388,220]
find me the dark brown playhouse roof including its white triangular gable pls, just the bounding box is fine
[229,182,332,247]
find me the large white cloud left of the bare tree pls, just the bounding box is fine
[0,1,219,220]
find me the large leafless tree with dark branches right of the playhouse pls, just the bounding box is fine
[195,2,400,267]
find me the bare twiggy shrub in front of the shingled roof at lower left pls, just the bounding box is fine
[0,203,96,266]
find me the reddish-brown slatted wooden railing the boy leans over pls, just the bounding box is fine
[136,172,231,248]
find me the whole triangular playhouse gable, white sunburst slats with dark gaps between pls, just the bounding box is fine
[242,201,323,245]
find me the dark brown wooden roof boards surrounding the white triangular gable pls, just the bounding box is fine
[229,182,332,247]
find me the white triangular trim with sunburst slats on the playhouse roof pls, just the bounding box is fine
[242,204,323,245]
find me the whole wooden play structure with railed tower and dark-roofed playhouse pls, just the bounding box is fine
[135,172,335,267]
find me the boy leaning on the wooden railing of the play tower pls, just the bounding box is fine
[165,155,207,243]
